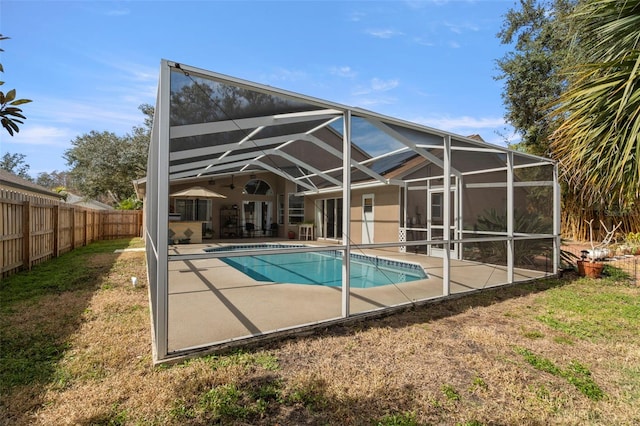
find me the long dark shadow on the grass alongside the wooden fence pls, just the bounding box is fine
[0,239,139,424]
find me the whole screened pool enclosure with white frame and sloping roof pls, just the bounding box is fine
[138,61,560,362]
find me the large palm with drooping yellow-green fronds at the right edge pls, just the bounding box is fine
[552,0,640,212]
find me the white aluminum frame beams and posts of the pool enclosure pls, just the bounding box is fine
[145,60,560,362]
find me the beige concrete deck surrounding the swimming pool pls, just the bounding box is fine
[162,239,550,352]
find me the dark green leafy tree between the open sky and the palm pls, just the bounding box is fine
[496,0,576,156]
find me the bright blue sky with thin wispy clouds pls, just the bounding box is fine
[0,0,514,177]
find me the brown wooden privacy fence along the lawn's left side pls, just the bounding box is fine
[0,190,142,278]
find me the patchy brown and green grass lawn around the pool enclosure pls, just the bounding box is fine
[0,239,640,425]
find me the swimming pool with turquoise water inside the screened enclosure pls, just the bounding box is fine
[205,244,428,288]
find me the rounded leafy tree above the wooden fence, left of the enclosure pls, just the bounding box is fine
[64,105,153,204]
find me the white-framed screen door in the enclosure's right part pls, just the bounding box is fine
[427,188,458,259]
